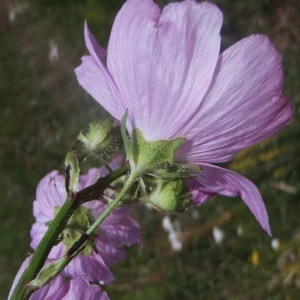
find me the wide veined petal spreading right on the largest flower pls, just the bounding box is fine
[178,35,292,163]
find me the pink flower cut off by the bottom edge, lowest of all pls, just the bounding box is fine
[8,256,109,300]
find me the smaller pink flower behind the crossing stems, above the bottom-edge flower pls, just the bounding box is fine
[31,168,139,284]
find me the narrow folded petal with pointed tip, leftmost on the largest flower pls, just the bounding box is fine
[75,24,125,120]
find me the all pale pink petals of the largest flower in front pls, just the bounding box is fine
[76,0,291,234]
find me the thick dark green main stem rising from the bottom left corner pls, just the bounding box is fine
[10,165,128,300]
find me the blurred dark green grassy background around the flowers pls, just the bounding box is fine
[0,0,300,300]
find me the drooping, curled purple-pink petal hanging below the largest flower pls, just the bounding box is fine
[191,164,271,235]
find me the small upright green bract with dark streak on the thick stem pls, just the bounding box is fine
[65,150,80,193]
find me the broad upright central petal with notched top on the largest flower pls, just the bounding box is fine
[107,0,222,140]
